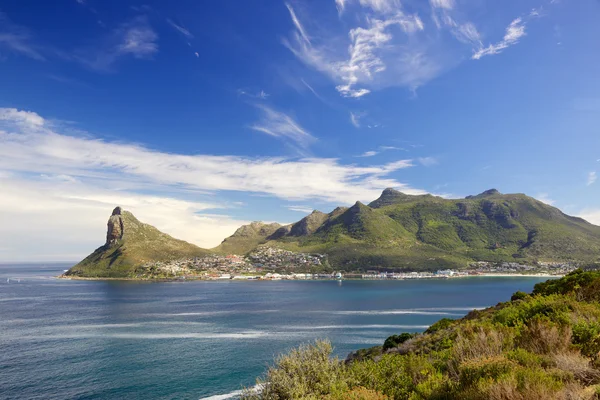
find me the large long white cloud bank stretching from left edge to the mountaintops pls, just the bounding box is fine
[0,108,432,261]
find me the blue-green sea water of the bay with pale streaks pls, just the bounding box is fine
[0,264,543,400]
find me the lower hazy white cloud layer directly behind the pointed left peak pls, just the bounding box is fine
[0,176,247,261]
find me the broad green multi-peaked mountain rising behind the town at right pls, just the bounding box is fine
[224,188,600,270]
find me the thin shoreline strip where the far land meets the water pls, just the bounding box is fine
[55,273,565,282]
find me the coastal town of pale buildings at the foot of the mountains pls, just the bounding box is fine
[136,247,578,280]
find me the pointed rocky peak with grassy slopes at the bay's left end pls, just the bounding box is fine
[65,207,208,278]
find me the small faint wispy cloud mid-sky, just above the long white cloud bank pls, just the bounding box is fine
[251,105,316,148]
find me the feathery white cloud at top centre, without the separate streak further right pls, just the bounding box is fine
[283,1,436,98]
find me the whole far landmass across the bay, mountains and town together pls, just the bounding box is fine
[65,189,600,279]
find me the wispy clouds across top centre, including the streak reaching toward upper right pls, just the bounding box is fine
[283,0,542,98]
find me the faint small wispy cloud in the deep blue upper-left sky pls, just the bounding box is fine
[74,16,158,71]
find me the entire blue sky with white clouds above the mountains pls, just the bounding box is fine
[0,0,600,261]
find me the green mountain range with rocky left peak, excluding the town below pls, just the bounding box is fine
[64,189,600,277]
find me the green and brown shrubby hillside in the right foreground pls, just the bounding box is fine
[243,270,600,400]
